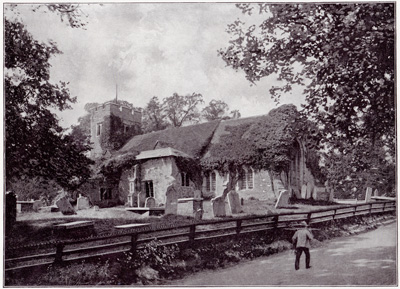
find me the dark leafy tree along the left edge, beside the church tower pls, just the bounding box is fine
[4,6,91,189]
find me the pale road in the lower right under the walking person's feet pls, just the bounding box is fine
[171,223,397,286]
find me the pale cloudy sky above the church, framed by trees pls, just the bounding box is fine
[5,3,304,127]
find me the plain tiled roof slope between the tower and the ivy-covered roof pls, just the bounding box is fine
[118,121,220,157]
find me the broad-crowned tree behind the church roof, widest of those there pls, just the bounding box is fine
[163,93,203,127]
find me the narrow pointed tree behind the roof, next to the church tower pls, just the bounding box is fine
[142,96,168,133]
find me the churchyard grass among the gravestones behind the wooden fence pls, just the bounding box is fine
[5,198,338,249]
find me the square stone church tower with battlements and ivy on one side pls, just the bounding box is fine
[90,99,142,159]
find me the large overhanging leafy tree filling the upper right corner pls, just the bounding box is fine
[219,3,395,152]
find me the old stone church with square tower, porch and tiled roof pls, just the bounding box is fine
[76,101,326,207]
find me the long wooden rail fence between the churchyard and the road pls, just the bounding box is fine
[5,201,396,272]
